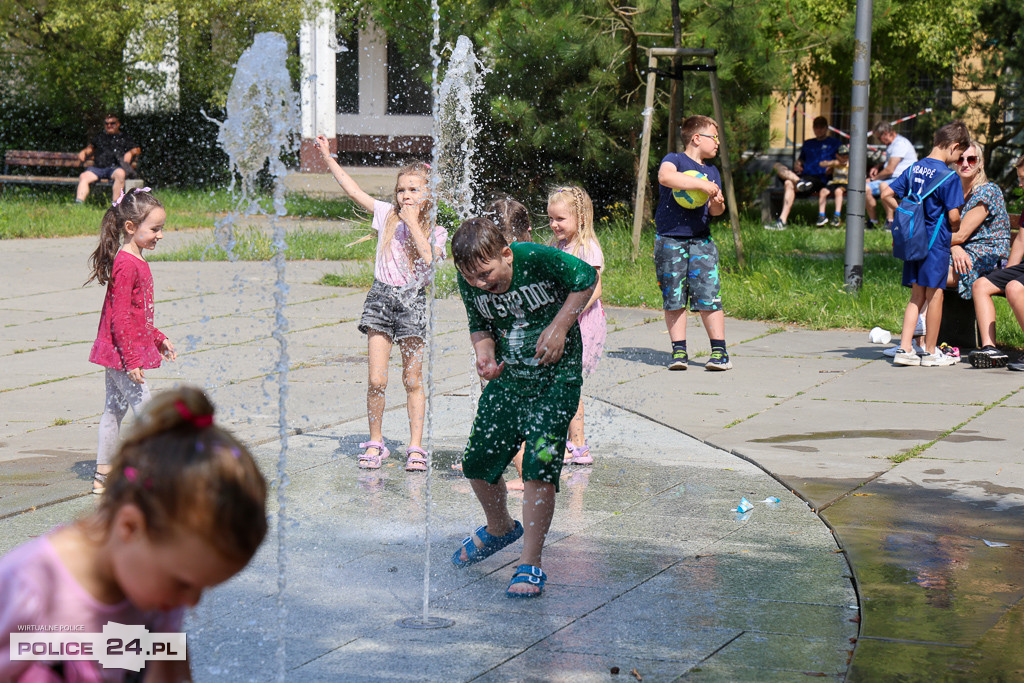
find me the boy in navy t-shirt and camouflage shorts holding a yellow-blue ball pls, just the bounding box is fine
[654,116,732,370]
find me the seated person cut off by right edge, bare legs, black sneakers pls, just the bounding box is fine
[968,156,1024,372]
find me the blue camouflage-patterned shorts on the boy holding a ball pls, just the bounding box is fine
[654,234,722,310]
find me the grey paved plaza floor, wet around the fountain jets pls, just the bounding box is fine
[0,234,1024,681]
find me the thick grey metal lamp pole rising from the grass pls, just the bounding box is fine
[844,0,871,292]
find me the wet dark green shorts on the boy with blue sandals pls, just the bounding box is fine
[462,380,581,490]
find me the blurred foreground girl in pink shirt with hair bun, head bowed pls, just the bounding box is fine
[0,387,267,683]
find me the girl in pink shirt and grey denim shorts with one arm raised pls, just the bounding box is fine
[316,135,447,472]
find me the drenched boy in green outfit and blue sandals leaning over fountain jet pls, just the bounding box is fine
[452,218,597,598]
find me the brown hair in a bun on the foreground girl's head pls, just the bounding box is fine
[96,387,267,563]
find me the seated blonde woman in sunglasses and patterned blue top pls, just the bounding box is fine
[946,140,1010,299]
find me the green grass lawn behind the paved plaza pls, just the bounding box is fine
[6,187,1024,348]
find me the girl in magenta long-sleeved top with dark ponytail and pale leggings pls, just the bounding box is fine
[86,187,177,494]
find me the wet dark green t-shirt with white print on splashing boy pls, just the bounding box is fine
[459,242,597,393]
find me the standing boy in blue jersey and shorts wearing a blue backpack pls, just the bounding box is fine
[882,121,971,367]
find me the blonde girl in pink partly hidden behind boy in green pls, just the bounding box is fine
[548,185,608,465]
